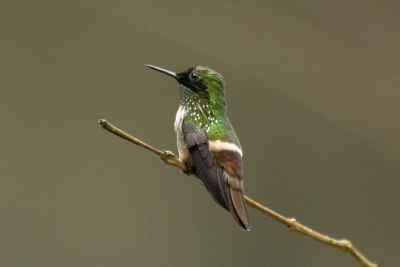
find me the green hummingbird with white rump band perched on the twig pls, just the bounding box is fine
[146,65,250,231]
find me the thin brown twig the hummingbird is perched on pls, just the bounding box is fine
[99,119,378,267]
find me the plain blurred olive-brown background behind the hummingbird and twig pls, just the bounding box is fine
[0,0,400,266]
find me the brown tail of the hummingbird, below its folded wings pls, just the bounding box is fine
[227,186,250,231]
